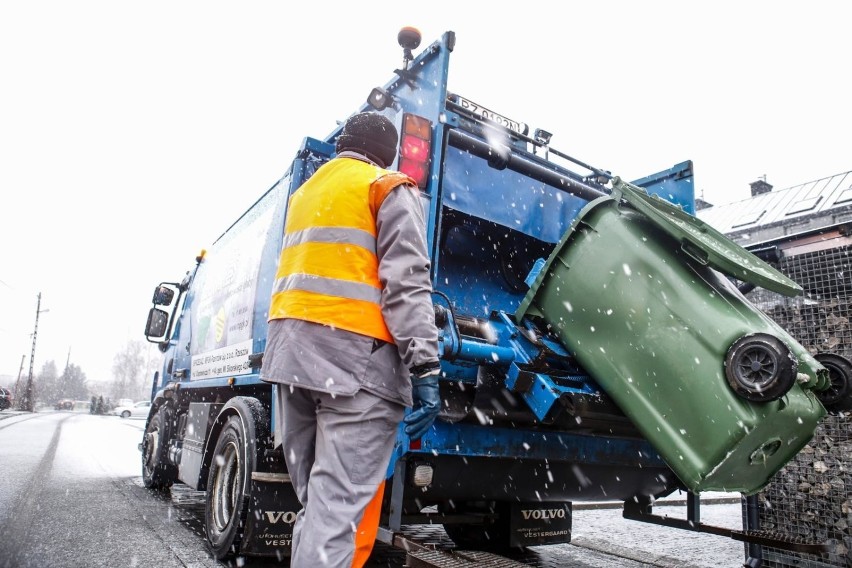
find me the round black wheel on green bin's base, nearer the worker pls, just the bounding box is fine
[725,333,799,402]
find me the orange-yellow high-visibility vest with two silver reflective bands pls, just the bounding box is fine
[269,158,416,343]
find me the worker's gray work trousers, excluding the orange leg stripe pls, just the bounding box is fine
[278,385,405,568]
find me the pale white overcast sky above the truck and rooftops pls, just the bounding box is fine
[0,0,852,386]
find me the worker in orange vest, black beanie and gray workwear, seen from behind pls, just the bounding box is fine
[261,113,441,568]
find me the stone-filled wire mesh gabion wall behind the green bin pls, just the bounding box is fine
[747,246,852,568]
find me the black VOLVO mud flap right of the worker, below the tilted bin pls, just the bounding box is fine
[509,501,571,547]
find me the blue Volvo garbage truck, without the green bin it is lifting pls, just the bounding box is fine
[140,28,772,558]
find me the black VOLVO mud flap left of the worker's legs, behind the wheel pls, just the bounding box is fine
[240,471,302,560]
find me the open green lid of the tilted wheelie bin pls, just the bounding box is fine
[612,177,802,296]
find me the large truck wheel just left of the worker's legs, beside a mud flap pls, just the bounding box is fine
[204,416,255,560]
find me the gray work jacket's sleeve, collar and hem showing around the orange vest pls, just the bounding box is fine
[261,151,438,406]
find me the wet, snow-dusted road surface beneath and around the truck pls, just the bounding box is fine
[0,411,744,568]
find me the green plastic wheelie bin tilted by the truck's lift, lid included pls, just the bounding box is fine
[516,178,830,494]
